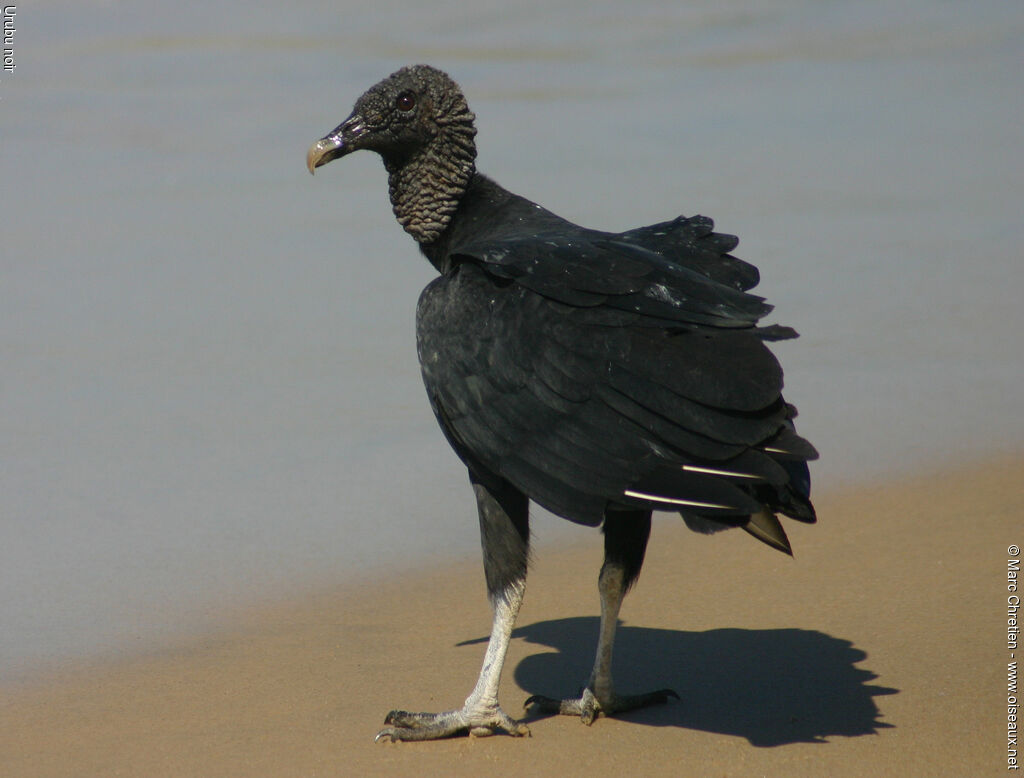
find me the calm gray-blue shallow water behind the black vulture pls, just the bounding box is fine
[0,0,1024,679]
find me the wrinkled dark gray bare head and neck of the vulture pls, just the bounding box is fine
[306,64,476,244]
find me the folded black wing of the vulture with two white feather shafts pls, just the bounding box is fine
[419,217,815,548]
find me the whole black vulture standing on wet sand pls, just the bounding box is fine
[306,64,817,741]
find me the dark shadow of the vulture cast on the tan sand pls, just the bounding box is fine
[462,617,899,746]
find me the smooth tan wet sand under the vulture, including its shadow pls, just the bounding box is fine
[0,458,1024,776]
